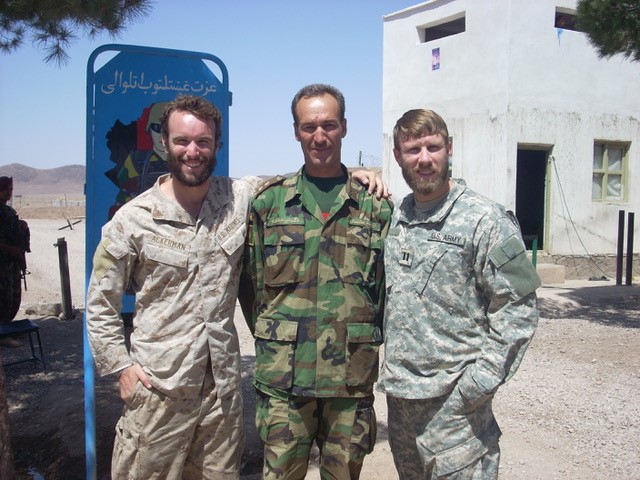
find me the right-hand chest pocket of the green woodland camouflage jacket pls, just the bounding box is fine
[342,218,383,286]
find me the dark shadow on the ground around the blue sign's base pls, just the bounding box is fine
[0,314,262,480]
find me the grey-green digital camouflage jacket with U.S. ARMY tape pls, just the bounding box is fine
[379,183,540,405]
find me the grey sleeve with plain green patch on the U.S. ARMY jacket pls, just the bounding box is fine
[458,219,541,406]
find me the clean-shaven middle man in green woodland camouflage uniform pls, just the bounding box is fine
[240,84,391,480]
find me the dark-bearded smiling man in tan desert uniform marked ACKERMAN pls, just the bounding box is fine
[87,96,260,480]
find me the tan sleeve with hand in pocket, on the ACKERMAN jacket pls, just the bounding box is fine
[86,219,133,375]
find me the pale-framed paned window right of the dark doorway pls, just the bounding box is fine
[591,142,629,201]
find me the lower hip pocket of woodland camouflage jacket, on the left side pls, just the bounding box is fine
[254,318,298,389]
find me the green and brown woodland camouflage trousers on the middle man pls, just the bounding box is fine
[256,391,376,480]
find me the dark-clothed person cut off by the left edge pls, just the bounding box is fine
[0,177,30,347]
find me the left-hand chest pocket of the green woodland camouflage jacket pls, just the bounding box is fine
[264,219,305,287]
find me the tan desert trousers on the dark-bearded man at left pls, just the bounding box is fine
[111,367,244,480]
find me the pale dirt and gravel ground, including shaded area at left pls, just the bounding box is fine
[0,212,640,480]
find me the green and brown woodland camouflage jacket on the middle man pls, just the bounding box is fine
[240,169,392,398]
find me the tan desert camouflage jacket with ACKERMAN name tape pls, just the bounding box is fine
[87,175,260,396]
